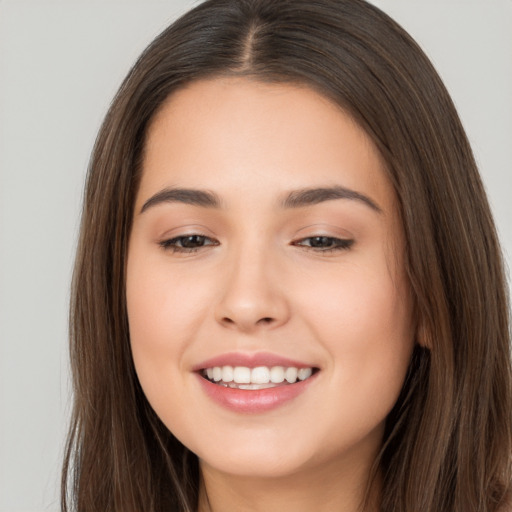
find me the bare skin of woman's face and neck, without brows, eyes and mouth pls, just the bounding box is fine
[127,78,414,512]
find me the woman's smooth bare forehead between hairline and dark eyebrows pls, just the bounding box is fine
[138,77,394,212]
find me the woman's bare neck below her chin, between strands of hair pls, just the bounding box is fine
[198,456,380,512]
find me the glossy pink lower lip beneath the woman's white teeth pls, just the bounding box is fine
[197,372,318,413]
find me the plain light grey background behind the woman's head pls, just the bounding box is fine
[0,0,512,512]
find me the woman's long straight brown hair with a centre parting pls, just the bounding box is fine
[62,0,512,512]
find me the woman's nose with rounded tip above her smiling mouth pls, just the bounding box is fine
[215,246,290,333]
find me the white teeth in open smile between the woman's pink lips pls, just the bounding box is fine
[200,366,318,390]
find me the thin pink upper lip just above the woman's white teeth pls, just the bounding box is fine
[192,352,317,371]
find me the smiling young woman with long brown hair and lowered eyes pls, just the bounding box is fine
[63,0,512,512]
